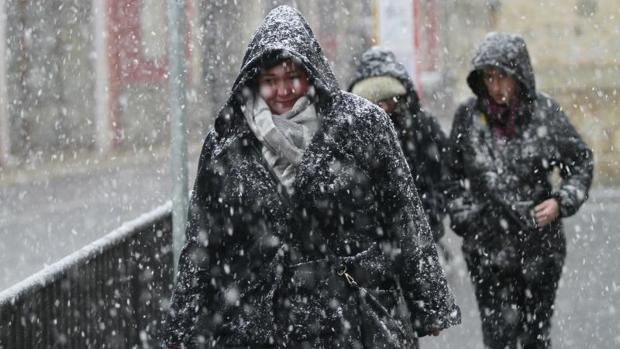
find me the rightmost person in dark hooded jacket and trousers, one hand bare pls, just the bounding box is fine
[448,33,593,348]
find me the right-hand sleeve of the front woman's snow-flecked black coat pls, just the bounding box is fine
[361,106,460,336]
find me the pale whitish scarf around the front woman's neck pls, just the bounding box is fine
[243,96,319,194]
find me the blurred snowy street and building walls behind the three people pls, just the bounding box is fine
[0,0,620,348]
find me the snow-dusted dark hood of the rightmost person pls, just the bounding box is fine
[467,33,536,101]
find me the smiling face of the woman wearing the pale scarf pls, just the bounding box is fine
[258,59,310,115]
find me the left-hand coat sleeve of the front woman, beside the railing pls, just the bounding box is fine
[163,131,215,347]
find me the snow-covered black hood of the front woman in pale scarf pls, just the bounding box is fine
[215,6,339,135]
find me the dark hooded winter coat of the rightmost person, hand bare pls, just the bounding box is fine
[449,33,593,280]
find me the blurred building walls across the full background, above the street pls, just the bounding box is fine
[0,0,620,183]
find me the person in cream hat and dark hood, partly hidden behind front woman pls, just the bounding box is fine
[349,47,447,242]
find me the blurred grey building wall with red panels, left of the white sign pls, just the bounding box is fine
[0,0,371,169]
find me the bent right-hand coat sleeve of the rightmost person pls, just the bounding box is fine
[549,102,594,217]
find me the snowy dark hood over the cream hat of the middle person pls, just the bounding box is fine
[348,47,420,114]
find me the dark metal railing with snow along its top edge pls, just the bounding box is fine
[0,203,173,349]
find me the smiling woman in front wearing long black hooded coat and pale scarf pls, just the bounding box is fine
[164,6,460,348]
